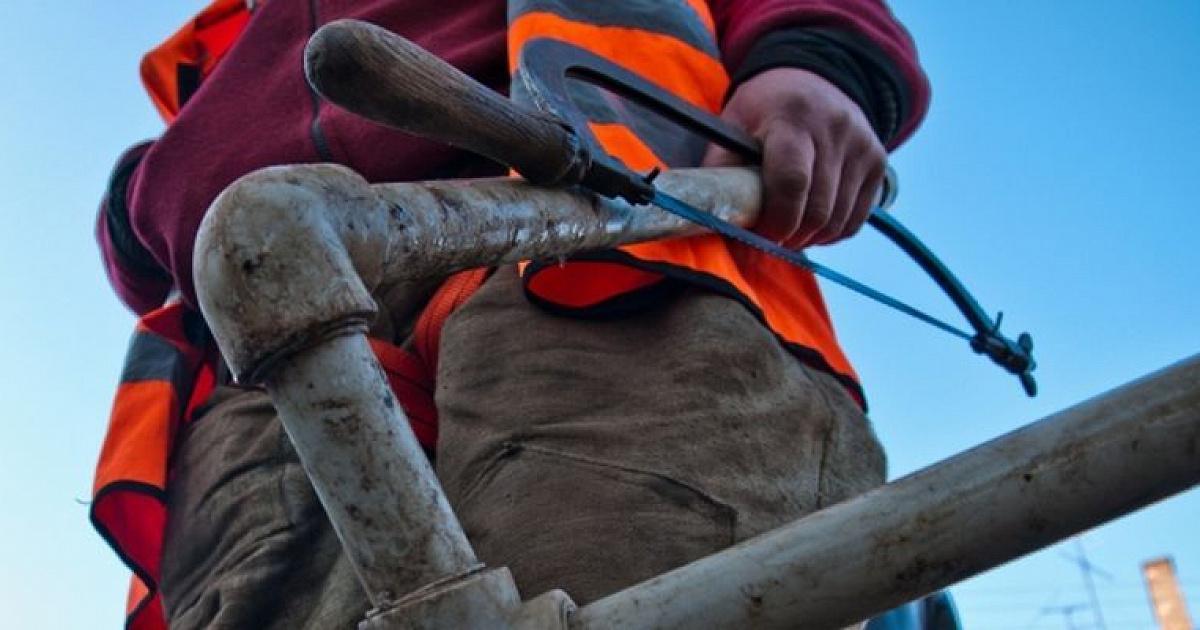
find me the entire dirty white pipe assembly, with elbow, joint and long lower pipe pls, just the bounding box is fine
[196,159,1200,629]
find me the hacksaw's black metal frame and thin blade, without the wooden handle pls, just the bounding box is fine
[521,38,1037,396]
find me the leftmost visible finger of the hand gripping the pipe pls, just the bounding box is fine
[755,124,816,242]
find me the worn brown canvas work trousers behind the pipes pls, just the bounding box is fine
[162,269,884,628]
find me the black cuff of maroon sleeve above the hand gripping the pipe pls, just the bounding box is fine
[730,28,911,144]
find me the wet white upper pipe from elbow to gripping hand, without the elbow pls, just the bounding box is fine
[374,168,762,289]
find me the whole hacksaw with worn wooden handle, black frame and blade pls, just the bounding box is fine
[305,20,1037,396]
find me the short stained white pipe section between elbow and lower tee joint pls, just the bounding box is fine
[266,335,480,606]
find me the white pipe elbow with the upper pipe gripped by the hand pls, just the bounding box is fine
[193,164,761,383]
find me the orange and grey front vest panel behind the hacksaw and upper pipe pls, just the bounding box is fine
[509,0,863,402]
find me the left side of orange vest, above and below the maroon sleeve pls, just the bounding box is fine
[89,0,250,630]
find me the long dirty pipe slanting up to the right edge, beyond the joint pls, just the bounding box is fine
[572,355,1200,630]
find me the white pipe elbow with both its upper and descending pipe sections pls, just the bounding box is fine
[193,159,760,617]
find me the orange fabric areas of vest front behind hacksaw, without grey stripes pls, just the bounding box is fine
[509,0,857,388]
